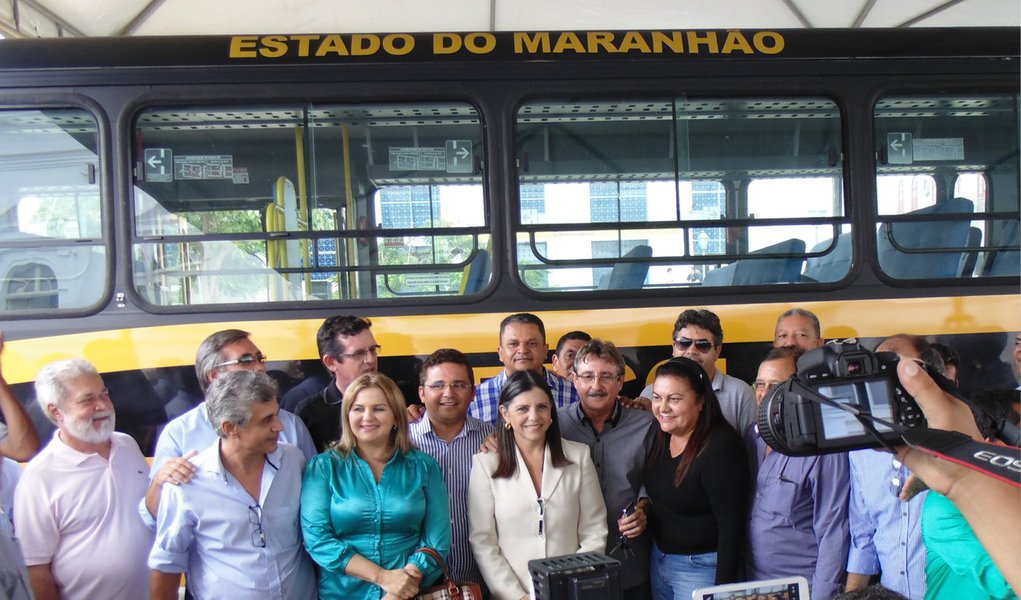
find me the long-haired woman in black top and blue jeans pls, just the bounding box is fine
[645,357,750,600]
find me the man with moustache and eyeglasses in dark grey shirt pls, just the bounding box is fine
[556,338,660,600]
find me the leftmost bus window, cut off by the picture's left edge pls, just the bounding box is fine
[0,108,109,316]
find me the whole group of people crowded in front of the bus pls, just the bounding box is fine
[0,308,1021,600]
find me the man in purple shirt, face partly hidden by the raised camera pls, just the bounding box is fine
[744,347,850,599]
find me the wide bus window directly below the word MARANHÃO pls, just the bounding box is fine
[516,98,850,292]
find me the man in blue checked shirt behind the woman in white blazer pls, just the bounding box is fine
[470,312,578,424]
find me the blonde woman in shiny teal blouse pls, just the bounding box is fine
[301,372,450,600]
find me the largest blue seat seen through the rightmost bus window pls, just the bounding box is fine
[877,198,974,279]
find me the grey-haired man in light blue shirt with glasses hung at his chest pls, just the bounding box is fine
[149,370,315,600]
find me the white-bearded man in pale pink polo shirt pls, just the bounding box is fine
[14,358,152,600]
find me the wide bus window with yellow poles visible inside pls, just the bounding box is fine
[134,103,492,306]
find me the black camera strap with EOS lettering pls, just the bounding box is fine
[902,428,1021,488]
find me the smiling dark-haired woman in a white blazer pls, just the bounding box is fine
[468,370,606,600]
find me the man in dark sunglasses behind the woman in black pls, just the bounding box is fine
[641,308,756,433]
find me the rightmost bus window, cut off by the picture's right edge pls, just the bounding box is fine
[875,95,1021,280]
